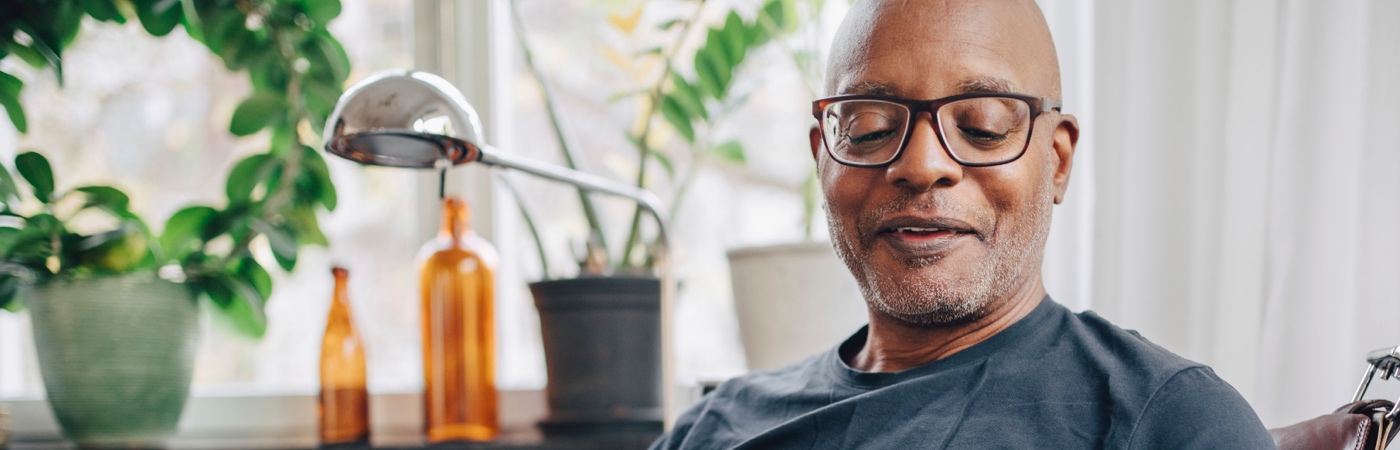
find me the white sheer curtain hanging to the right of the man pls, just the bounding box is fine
[1042,0,1400,426]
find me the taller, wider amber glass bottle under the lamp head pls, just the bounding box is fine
[419,198,500,443]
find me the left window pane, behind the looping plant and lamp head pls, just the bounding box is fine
[0,0,437,398]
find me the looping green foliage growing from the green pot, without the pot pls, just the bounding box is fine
[0,0,350,336]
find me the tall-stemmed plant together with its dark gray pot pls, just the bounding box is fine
[507,0,817,433]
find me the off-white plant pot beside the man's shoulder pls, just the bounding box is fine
[729,243,867,370]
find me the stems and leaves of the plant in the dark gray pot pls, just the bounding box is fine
[508,0,823,275]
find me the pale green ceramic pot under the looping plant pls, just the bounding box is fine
[24,273,199,449]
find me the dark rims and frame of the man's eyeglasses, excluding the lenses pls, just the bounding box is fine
[812,93,1063,167]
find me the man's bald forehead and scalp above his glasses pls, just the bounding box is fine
[826,0,1060,100]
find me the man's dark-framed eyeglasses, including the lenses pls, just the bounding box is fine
[812,93,1060,167]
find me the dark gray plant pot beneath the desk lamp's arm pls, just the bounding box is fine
[531,276,662,436]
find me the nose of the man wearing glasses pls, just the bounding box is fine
[885,112,963,192]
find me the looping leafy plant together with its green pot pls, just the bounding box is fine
[0,0,349,447]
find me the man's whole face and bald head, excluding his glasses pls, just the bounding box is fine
[812,1,1077,324]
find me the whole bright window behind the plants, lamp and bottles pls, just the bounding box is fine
[0,0,844,437]
